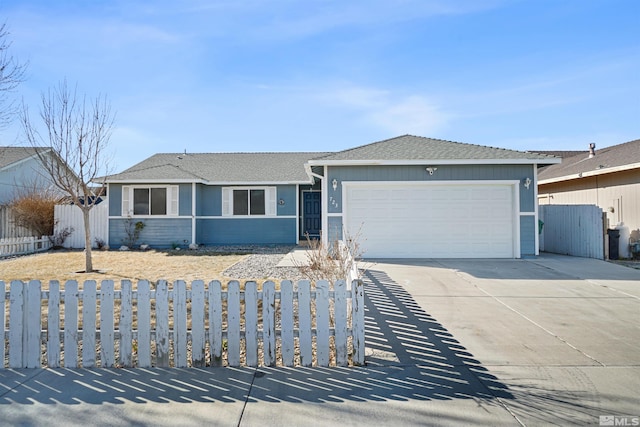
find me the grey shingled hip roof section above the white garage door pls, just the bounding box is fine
[309,135,561,165]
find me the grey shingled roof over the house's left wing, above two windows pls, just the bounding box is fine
[107,153,327,183]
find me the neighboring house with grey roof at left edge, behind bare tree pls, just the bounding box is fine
[0,147,58,205]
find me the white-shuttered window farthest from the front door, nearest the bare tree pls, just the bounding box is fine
[122,185,179,216]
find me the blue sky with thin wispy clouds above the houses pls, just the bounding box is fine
[0,0,640,172]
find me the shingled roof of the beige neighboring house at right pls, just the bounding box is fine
[538,139,640,184]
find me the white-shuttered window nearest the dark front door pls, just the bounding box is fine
[222,187,276,216]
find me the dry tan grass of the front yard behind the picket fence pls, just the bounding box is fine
[0,250,246,284]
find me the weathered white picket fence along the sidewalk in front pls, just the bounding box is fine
[0,280,365,368]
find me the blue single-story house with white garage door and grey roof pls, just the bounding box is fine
[107,135,560,258]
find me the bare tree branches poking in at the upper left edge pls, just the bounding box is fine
[0,24,27,129]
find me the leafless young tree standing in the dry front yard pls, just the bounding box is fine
[20,81,114,272]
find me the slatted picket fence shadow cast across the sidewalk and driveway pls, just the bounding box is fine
[0,271,513,407]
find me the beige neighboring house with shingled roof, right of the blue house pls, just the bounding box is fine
[538,140,640,252]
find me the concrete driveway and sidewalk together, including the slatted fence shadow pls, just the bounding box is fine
[0,256,640,426]
